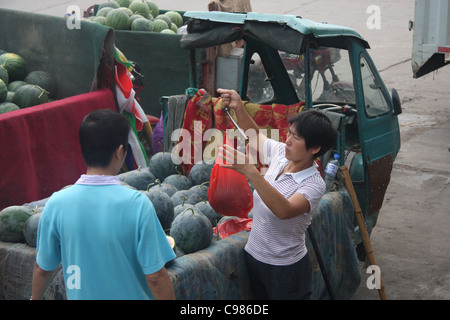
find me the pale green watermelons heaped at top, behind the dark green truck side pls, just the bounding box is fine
[86,0,183,34]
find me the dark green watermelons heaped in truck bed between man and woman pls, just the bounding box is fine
[0,152,239,256]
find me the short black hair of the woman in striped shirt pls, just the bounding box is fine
[288,109,337,157]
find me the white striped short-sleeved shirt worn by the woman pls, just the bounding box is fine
[245,139,325,265]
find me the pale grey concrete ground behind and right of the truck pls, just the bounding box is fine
[0,0,450,300]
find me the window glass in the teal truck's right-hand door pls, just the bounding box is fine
[360,55,390,117]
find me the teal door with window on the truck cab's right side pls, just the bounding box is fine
[353,49,400,215]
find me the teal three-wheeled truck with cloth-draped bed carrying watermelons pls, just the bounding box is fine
[0,12,401,299]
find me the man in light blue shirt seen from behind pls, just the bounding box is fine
[32,109,175,300]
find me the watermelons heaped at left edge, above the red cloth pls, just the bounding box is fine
[0,49,56,114]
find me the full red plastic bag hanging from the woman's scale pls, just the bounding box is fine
[208,135,253,218]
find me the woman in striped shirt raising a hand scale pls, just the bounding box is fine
[217,89,337,300]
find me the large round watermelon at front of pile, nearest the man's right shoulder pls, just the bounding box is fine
[170,208,213,254]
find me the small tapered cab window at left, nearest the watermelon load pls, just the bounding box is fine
[247,53,274,103]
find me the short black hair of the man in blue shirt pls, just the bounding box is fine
[79,109,130,168]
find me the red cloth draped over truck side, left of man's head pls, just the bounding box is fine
[0,89,115,210]
